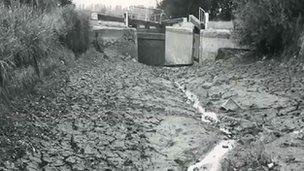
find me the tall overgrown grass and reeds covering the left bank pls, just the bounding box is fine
[0,0,90,101]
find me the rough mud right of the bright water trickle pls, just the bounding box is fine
[169,55,304,170]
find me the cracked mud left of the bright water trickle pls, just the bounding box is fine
[0,48,222,170]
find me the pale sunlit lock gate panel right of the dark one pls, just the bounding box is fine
[165,27,193,66]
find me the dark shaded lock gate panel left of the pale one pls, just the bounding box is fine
[137,32,165,66]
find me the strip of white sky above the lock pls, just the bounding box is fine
[73,0,160,7]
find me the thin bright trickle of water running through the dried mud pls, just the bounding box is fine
[175,82,236,171]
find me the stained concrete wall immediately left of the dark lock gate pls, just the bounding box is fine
[93,27,138,60]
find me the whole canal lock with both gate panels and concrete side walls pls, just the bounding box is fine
[92,11,240,66]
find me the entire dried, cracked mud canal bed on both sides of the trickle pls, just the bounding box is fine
[0,50,304,171]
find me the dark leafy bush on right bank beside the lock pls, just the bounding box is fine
[235,0,304,54]
